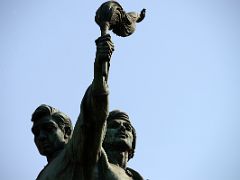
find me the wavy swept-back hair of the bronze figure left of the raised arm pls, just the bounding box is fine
[31,104,73,136]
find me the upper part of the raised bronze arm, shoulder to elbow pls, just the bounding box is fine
[67,86,108,165]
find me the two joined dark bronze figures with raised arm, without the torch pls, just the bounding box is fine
[32,1,143,180]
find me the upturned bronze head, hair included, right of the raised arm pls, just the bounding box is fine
[103,110,136,160]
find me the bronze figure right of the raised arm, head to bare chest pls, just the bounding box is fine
[101,110,143,180]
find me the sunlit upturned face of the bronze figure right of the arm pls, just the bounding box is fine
[104,119,133,150]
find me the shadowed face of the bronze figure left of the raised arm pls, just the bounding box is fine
[32,116,67,156]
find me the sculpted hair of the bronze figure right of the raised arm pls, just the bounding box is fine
[107,110,137,160]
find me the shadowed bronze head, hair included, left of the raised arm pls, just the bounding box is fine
[31,104,73,157]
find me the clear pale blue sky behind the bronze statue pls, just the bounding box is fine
[0,0,240,180]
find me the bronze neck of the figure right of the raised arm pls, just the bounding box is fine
[106,149,128,169]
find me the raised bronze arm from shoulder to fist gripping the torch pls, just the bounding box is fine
[65,35,113,166]
